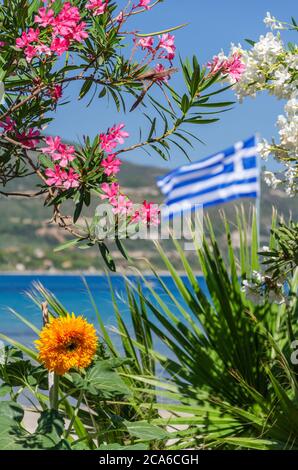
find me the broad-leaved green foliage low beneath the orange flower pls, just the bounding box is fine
[0,349,168,450]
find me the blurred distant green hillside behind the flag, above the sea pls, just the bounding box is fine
[0,163,298,272]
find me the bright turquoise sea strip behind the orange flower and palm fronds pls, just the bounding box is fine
[0,274,205,344]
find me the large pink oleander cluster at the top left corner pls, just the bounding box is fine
[16,2,88,62]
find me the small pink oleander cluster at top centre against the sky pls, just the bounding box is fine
[135,33,176,62]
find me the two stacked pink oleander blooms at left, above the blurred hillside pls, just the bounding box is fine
[41,136,80,189]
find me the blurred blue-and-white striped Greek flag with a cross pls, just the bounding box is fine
[157,137,260,218]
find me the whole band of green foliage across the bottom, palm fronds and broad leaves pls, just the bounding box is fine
[0,208,298,450]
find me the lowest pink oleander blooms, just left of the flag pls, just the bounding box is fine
[100,183,160,225]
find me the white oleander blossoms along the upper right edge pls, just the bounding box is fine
[231,12,298,196]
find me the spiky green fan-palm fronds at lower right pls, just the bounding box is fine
[114,209,298,449]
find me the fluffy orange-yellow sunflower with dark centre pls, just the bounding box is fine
[35,314,97,375]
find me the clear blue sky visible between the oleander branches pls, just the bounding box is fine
[47,0,297,168]
